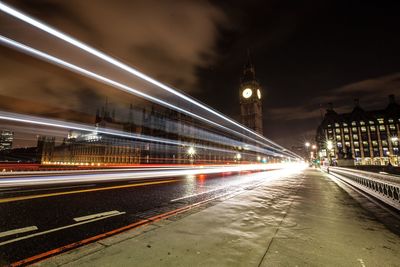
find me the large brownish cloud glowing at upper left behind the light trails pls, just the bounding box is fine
[0,0,226,119]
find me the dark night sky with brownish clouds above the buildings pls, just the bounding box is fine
[0,0,400,147]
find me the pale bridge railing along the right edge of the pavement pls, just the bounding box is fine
[324,167,400,210]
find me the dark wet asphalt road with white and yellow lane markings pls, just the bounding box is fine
[0,170,276,265]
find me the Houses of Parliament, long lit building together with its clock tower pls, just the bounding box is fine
[40,57,263,165]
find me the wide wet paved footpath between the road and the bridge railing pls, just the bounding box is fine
[34,169,400,266]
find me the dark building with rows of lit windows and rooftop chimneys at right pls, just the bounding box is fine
[316,95,400,166]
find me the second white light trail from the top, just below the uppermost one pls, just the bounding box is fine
[0,35,297,160]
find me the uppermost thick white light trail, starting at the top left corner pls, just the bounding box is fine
[0,2,300,158]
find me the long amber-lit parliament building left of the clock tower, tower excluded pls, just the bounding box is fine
[42,102,236,166]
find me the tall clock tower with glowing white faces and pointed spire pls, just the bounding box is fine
[240,56,263,134]
